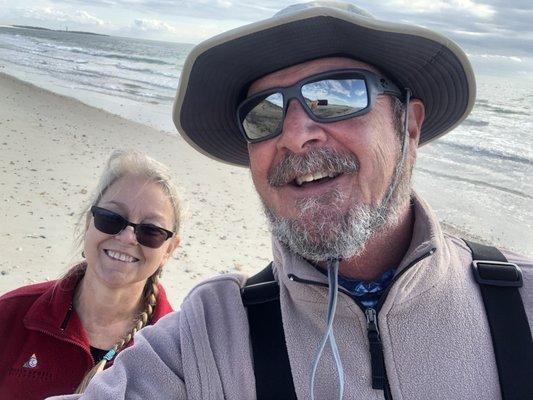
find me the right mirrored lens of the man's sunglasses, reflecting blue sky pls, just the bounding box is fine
[302,78,369,119]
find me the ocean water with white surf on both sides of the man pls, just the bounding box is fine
[0,27,533,256]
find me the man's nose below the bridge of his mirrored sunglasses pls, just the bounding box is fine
[277,99,327,154]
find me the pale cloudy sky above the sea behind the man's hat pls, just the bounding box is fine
[0,0,533,76]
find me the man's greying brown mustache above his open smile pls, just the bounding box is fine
[267,148,359,187]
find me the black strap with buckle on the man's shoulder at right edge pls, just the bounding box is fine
[465,240,533,400]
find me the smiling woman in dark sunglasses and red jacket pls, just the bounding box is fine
[0,152,180,400]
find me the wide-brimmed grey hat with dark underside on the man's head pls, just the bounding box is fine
[173,2,476,166]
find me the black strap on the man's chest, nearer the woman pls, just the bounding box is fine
[241,263,296,400]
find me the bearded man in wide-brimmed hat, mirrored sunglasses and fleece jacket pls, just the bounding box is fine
[48,2,533,400]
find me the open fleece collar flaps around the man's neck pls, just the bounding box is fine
[272,193,444,300]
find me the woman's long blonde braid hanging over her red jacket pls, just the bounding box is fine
[75,267,161,394]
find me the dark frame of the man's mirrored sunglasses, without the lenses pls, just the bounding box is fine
[237,68,404,143]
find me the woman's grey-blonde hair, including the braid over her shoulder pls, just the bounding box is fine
[69,150,181,394]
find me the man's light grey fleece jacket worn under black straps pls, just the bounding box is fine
[48,197,533,400]
